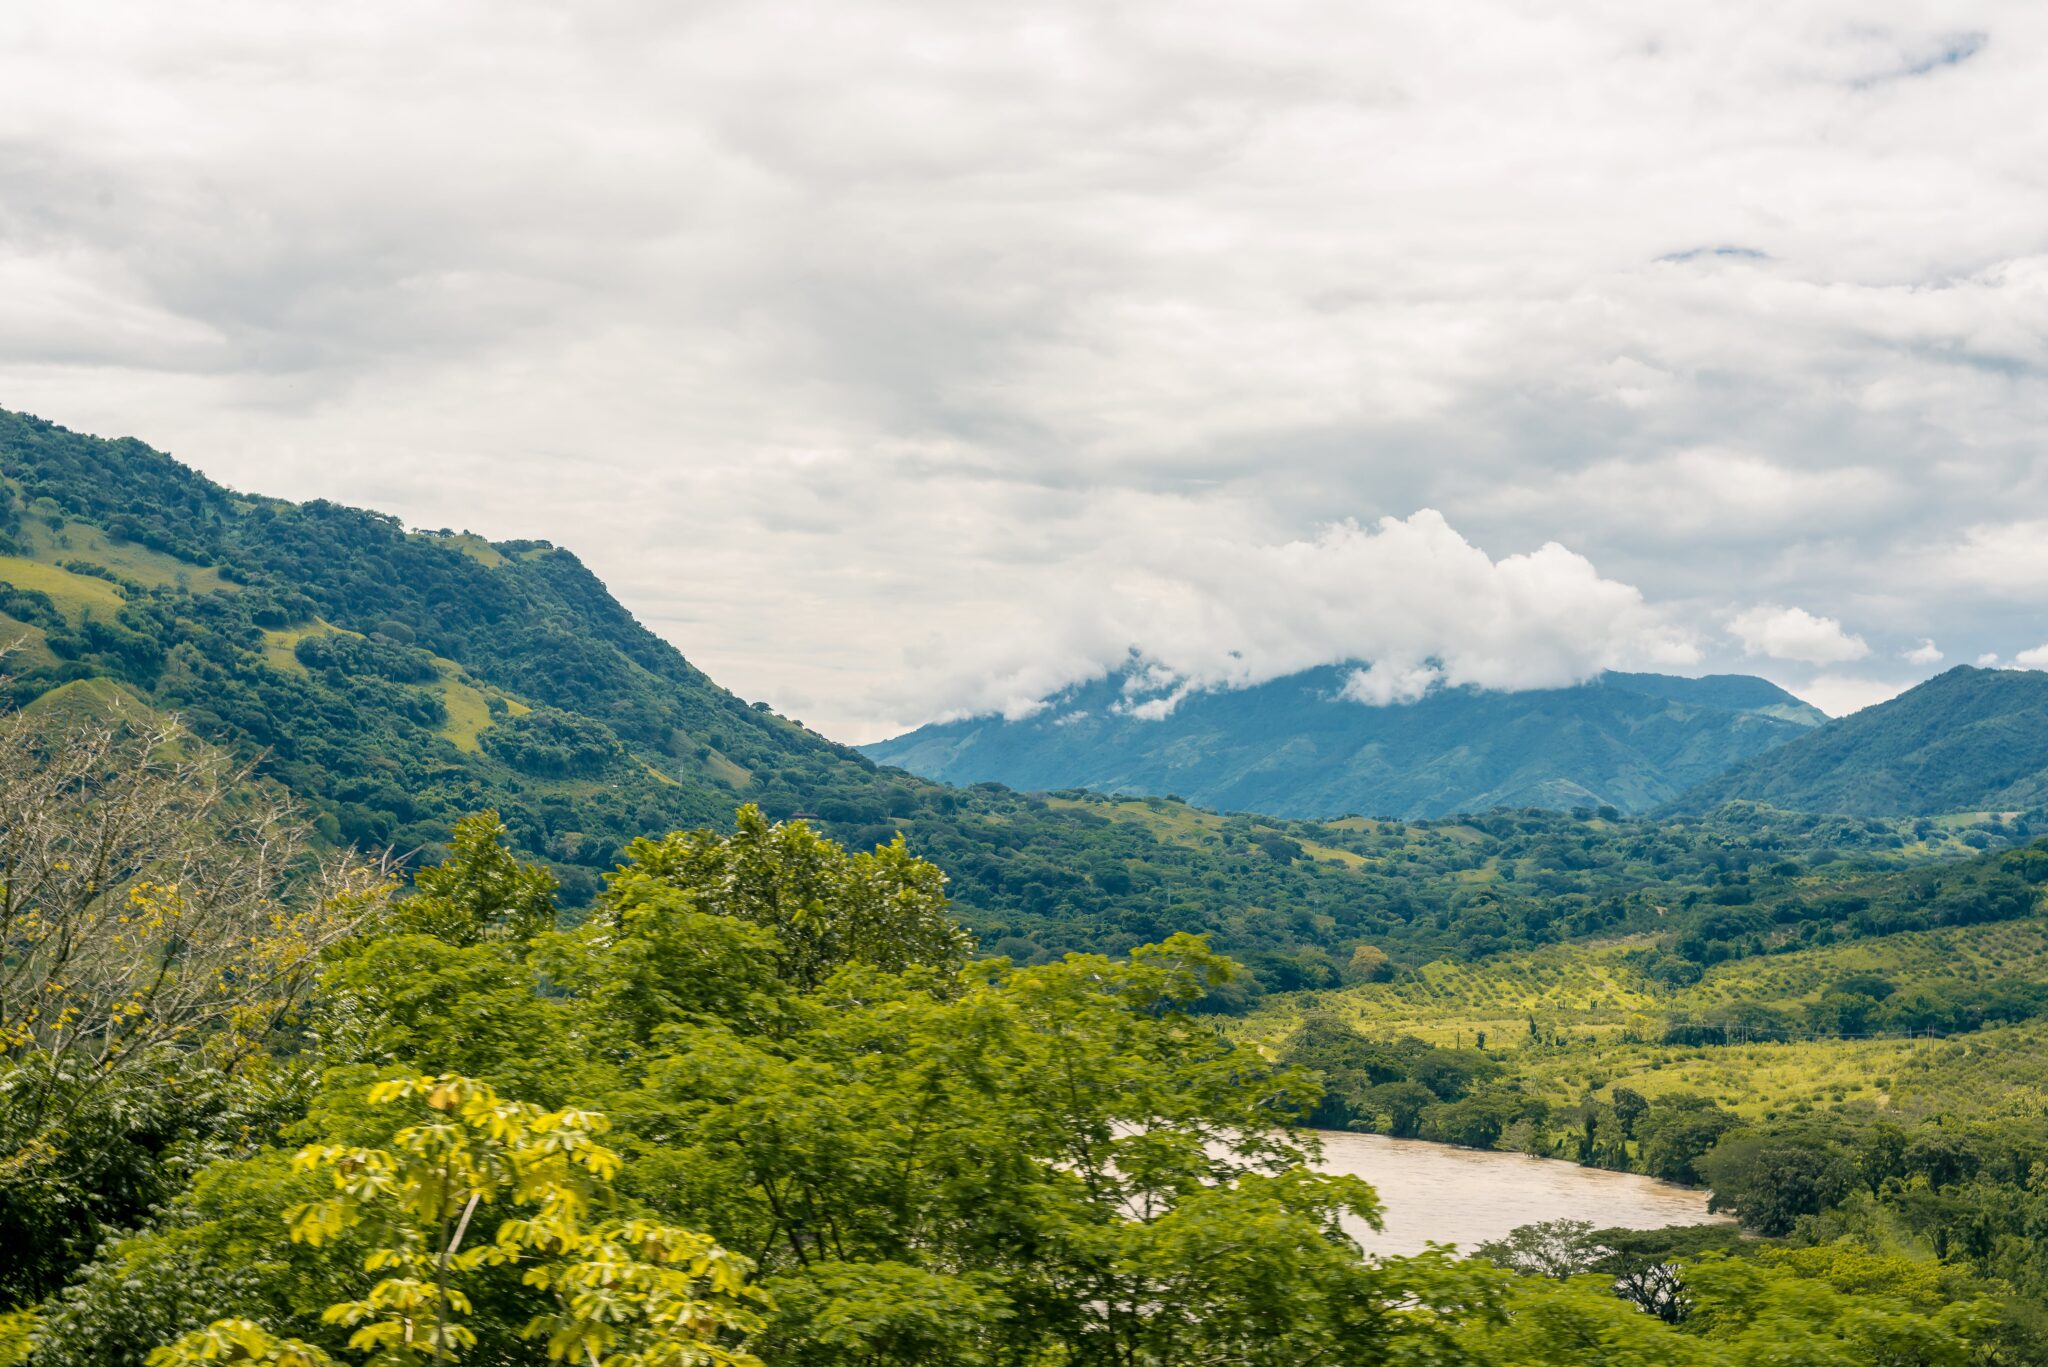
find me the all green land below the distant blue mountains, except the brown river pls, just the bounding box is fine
[0,405,2048,1367]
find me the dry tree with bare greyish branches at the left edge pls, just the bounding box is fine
[0,688,389,1183]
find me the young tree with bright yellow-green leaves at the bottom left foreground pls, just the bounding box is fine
[150,1074,764,1367]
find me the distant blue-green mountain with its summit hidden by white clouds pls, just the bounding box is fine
[864,666,1825,818]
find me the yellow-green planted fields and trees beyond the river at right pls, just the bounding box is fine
[1239,889,2048,1361]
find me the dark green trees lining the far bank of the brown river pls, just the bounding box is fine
[1280,1004,2048,1361]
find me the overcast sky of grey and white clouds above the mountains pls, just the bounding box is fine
[0,0,2048,740]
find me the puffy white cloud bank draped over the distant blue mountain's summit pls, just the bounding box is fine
[921,508,1700,719]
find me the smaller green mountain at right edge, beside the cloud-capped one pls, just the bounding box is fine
[1675,666,2048,816]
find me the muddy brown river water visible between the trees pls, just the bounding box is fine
[1321,1129,1716,1254]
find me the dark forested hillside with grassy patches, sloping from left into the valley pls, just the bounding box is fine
[0,414,2017,1004]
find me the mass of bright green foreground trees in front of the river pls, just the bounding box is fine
[0,814,2034,1367]
